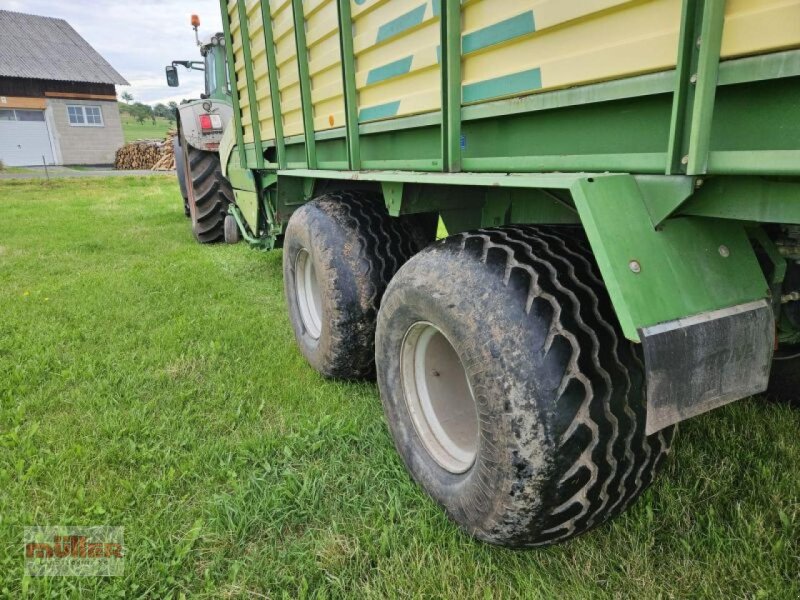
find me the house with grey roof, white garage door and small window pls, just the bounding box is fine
[0,10,128,166]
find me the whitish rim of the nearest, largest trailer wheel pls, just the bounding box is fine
[400,321,480,473]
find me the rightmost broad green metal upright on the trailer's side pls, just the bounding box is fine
[667,0,725,175]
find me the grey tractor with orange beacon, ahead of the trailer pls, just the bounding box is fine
[165,15,239,243]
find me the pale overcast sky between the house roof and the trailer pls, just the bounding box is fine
[0,0,222,104]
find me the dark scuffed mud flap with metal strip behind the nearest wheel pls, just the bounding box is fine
[639,300,775,435]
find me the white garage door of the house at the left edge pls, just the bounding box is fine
[0,109,54,167]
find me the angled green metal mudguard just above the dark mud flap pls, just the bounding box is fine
[572,175,769,341]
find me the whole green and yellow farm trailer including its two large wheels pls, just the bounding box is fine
[205,0,800,547]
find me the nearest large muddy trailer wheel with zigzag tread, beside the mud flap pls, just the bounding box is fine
[376,227,673,547]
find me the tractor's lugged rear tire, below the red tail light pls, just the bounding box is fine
[183,141,234,244]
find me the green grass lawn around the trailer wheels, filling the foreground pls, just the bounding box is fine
[0,177,800,599]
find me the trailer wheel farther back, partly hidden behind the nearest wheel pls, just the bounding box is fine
[283,192,419,379]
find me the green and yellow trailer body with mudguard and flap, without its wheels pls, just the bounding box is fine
[220,0,800,440]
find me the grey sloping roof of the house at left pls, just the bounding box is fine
[0,10,128,85]
